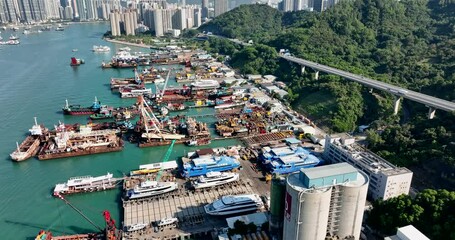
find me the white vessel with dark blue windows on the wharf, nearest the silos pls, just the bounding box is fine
[204,194,264,216]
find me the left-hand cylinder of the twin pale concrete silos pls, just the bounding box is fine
[283,174,332,240]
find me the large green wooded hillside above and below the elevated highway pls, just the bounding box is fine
[200,0,455,172]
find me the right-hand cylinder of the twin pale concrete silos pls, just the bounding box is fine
[335,172,369,239]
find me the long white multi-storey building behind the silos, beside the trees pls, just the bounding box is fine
[324,136,413,200]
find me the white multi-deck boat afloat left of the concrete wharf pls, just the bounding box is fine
[54,173,117,196]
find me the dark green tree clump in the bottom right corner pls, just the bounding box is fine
[367,189,455,239]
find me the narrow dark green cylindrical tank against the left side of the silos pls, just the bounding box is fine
[269,178,286,239]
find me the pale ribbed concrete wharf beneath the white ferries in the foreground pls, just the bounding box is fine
[123,179,257,239]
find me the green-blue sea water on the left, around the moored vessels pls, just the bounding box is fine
[0,23,239,239]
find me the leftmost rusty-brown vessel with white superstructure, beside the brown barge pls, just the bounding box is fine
[10,117,47,162]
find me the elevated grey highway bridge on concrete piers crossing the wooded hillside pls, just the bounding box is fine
[280,55,455,119]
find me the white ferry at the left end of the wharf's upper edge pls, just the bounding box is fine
[127,181,178,199]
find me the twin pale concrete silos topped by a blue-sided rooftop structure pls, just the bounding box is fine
[283,163,368,240]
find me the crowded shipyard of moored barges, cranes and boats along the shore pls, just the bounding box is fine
[11,41,330,239]
